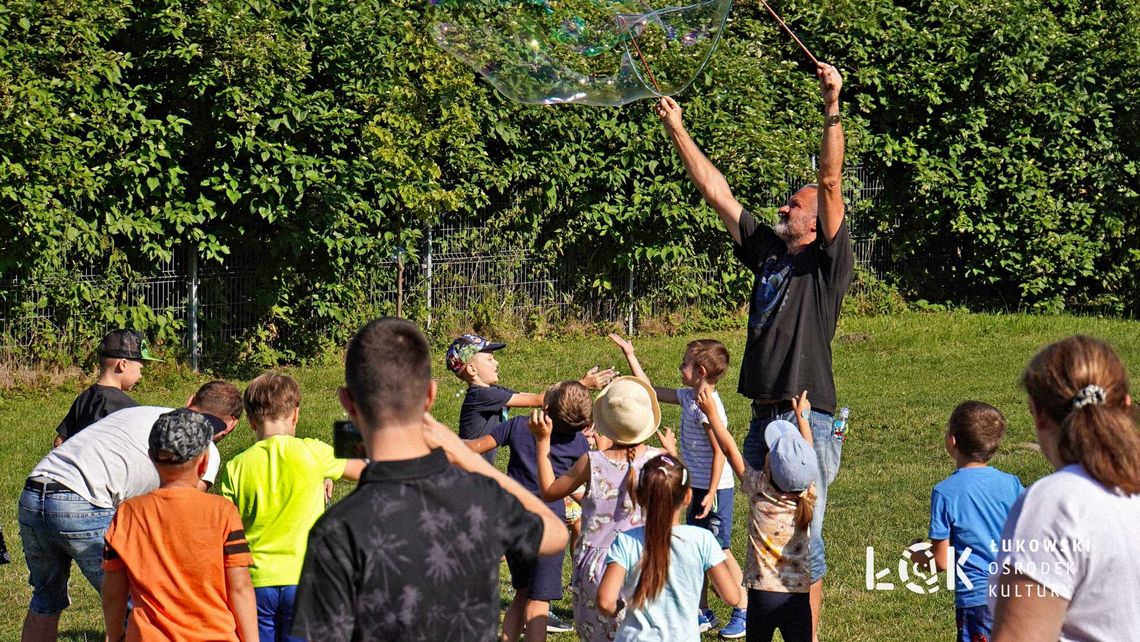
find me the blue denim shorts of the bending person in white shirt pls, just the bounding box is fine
[18,488,115,616]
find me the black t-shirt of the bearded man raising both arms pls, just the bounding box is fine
[734,211,855,413]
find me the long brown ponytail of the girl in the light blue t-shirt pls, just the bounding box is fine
[629,455,689,609]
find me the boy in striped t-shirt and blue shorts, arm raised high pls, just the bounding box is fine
[610,334,748,640]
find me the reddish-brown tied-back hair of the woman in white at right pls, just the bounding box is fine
[1021,335,1140,495]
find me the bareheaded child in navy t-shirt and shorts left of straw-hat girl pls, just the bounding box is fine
[465,381,593,642]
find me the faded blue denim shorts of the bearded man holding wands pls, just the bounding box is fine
[743,409,844,584]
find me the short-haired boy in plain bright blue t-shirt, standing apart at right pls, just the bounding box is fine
[913,401,1024,642]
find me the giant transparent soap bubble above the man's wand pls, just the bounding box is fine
[429,0,732,105]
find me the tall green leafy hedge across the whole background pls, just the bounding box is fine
[0,0,1140,359]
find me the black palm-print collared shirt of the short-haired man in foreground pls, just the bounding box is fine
[293,449,543,642]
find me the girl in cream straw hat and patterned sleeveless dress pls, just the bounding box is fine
[530,376,677,642]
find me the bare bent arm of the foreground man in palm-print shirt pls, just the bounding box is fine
[424,413,570,555]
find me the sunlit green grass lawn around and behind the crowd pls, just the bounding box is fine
[0,314,1140,641]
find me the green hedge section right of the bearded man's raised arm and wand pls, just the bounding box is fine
[802,0,1140,312]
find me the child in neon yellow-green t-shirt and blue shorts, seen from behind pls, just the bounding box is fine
[218,374,365,641]
